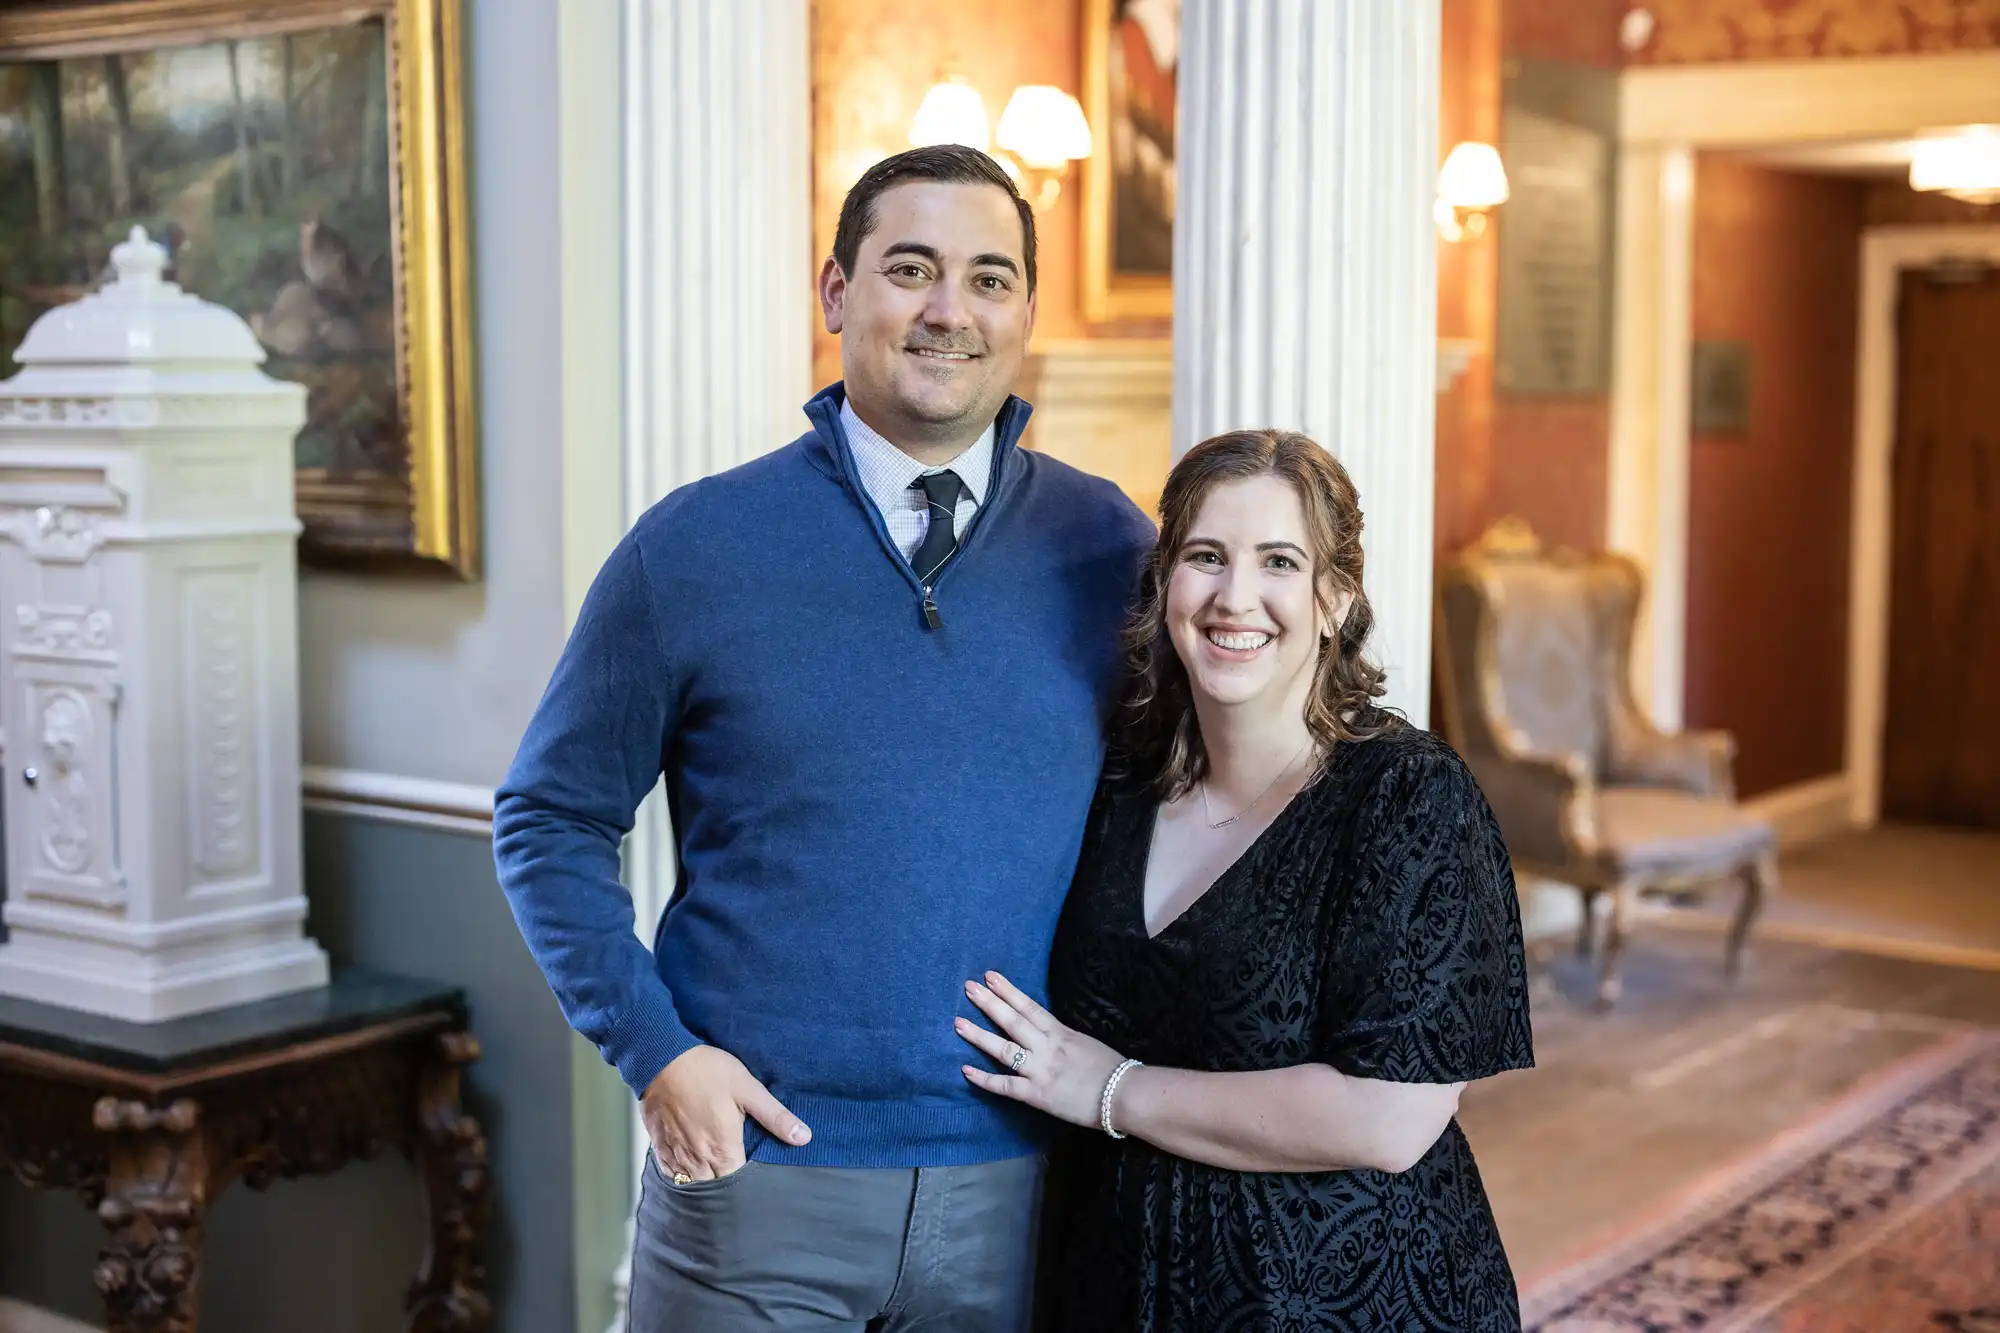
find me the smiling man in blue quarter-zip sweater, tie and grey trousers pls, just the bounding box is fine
[494,146,1152,1333]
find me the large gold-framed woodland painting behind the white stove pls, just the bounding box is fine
[0,0,478,578]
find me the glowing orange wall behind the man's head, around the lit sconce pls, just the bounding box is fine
[812,0,1086,384]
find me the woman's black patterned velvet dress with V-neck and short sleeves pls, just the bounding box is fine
[1042,725,1534,1333]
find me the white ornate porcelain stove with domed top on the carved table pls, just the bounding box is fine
[0,228,326,1023]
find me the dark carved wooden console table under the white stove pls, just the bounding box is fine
[0,971,492,1333]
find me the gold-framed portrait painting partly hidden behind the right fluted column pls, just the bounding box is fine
[1084,0,1180,322]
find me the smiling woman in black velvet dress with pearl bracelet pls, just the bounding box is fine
[958,430,1532,1333]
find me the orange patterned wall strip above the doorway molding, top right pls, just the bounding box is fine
[1624,0,2000,64]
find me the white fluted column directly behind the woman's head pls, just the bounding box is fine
[1174,0,1440,723]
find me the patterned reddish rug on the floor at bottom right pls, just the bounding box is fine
[1522,1033,2000,1333]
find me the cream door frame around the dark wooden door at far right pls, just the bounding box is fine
[1846,226,2000,827]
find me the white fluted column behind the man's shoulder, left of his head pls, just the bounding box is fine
[606,0,818,1331]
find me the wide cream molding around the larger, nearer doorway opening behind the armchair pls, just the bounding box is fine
[1606,52,2000,727]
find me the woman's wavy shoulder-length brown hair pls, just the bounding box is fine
[1112,430,1398,801]
